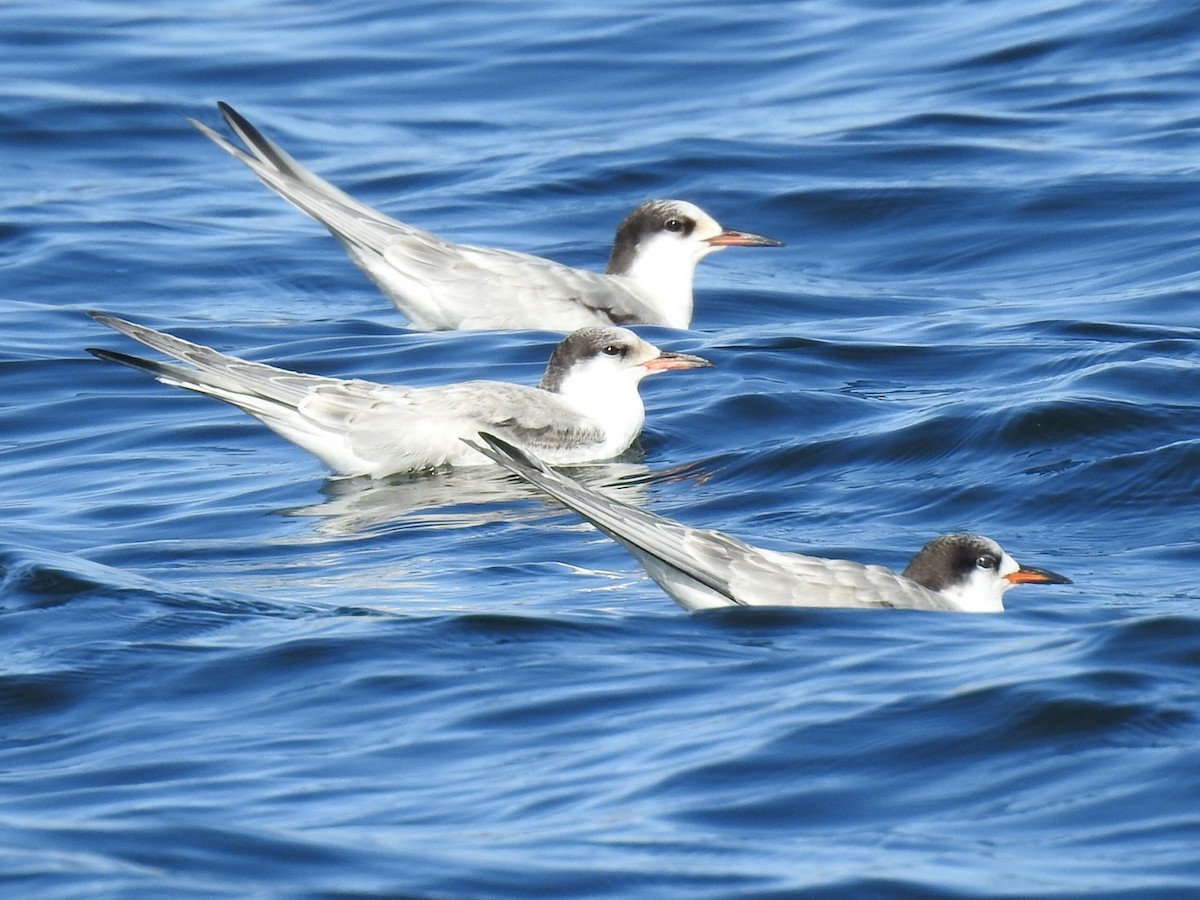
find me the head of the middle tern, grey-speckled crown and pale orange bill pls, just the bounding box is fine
[539,325,713,395]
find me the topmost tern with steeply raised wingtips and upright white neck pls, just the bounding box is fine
[190,103,782,331]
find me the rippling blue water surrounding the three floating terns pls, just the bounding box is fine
[0,0,1200,900]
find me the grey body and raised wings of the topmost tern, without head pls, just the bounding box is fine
[191,103,664,331]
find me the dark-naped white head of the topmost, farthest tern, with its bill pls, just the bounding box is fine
[607,200,784,280]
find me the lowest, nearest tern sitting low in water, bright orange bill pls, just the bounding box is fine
[473,433,1070,612]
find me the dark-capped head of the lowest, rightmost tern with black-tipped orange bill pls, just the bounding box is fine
[904,534,1070,612]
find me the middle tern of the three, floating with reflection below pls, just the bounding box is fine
[88,312,713,478]
